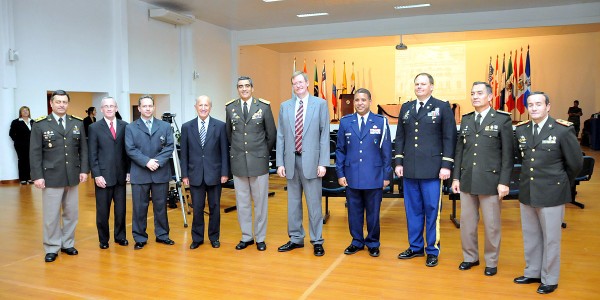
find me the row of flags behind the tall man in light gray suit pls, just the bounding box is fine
[292,57,356,114]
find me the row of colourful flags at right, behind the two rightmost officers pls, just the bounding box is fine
[487,46,531,116]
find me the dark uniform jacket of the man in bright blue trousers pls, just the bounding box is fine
[395,96,456,179]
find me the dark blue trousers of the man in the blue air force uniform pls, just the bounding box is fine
[346,187,383,248]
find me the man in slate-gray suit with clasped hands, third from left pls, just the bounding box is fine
[125,95,175,250]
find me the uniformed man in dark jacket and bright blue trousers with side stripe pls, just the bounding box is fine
[395,73,456,267]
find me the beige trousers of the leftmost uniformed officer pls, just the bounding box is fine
[42,185,79,253]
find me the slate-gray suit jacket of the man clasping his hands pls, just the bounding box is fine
[125,118,174,184]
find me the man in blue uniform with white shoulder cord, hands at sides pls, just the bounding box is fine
[335,88,392,257]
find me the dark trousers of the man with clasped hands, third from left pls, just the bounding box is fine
[131,183,169,243]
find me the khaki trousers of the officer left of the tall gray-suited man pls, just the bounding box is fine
[233,173,269,243]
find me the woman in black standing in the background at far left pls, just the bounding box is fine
[8,106,33,185]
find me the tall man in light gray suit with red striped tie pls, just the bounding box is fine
[276,71,329,256]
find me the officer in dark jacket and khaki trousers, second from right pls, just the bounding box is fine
[452,81,513,276]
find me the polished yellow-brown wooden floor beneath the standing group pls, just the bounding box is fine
[0,149,600,299]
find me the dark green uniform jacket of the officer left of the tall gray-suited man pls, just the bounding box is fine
[225,98,277,177]
